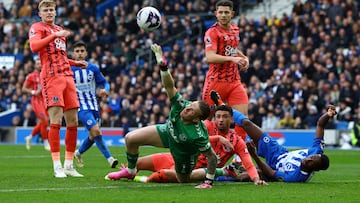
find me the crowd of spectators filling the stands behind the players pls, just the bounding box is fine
[0,0,360,132]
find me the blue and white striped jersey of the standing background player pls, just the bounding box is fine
[71,62,109,111]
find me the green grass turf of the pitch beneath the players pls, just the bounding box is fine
[0,145,360,203]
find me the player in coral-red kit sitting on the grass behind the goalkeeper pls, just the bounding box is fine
[105,102,266,185]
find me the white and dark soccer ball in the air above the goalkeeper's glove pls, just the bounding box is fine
[136,6,161,31]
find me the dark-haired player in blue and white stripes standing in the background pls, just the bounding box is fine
[71,41,118,168]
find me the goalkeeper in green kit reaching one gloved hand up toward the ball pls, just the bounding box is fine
[107,44,217,188]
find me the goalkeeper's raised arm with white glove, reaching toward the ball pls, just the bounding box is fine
[151,44,177,99]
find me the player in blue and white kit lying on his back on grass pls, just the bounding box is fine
[211,91,337,182]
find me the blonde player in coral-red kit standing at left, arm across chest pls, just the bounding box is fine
[29,0,86,178]
